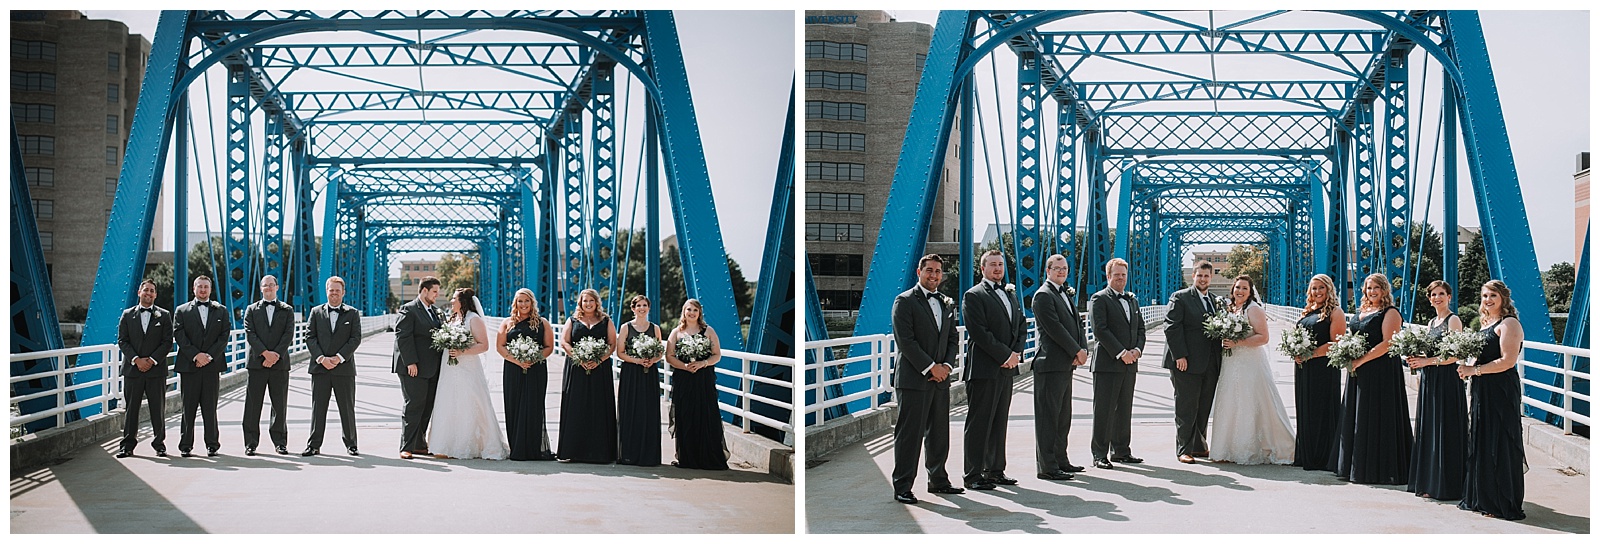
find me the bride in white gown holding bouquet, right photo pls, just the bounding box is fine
[1211,275,1294,464]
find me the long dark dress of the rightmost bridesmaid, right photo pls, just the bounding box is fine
[1459,318,1528,520]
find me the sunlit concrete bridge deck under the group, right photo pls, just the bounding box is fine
[803,316,1590,534]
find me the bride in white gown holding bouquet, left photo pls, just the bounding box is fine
[427,288,509,459]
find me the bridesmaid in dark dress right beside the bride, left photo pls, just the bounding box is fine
[494,288,555,461]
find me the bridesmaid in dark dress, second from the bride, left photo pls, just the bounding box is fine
[555,290,616,464]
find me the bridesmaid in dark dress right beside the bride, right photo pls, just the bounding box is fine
[1294,274,1346,472]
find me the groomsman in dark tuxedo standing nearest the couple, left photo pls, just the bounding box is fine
[301,275,362,458]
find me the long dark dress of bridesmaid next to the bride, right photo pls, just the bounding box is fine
[1294,312,1341,472]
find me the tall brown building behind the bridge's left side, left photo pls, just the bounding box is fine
[11,10,159,317]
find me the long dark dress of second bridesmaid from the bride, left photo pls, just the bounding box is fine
[555,317,616,462]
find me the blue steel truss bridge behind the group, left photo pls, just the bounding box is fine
[11,10,795,440]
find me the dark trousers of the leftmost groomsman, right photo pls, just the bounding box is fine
[890,387,950,494]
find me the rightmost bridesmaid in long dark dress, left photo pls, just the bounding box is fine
[667,299,728,470]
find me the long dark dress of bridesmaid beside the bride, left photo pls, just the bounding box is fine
[501,318,555,461]
